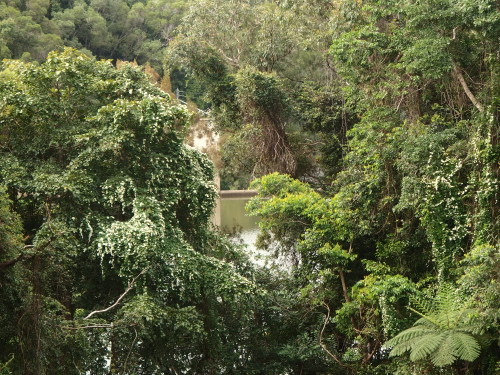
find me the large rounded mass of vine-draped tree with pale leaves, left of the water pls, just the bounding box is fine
[0,49,255,375]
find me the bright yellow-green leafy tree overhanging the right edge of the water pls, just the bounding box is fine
[247,174,422,370]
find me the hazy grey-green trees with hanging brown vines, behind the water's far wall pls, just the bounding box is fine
[167,0,342,187]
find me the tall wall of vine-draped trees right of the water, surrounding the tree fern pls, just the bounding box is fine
[235,0,500,374]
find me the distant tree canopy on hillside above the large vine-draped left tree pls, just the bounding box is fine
[0,0,188,70]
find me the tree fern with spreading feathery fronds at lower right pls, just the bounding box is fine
[385,288,481,367]
